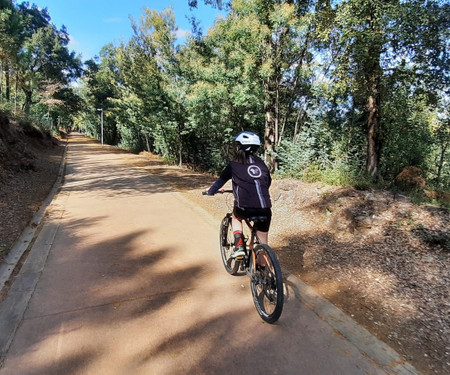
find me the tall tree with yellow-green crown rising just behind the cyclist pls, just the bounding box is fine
[192,0,312,170]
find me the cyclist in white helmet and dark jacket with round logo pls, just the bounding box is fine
[207,131,272,258]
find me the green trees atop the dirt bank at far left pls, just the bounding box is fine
[0,0,81,131]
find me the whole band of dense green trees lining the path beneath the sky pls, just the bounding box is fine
[0,0,450,190]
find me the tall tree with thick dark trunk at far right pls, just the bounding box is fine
[333,0,448,177]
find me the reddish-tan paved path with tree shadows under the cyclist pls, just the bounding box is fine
[0,137,415,375]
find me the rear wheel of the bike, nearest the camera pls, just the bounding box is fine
[250,244,284,323]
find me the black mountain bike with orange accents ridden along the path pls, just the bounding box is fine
[203,190,284,323]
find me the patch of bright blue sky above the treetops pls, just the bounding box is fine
[27,0,225,61]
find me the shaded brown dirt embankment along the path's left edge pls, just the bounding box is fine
[0,113,64,261]
